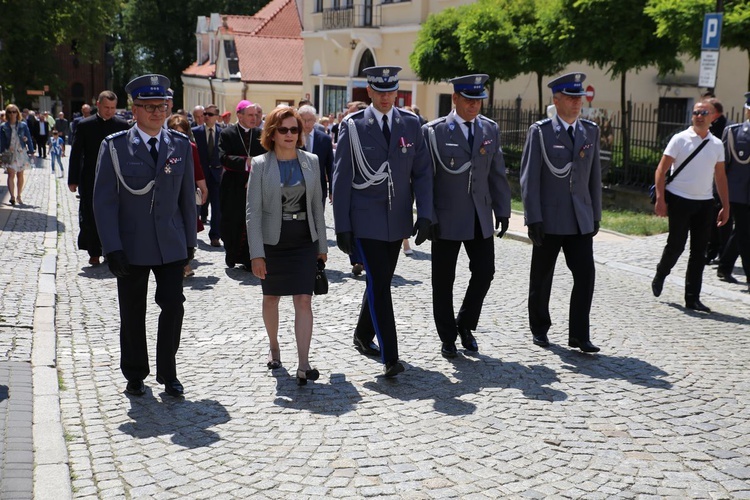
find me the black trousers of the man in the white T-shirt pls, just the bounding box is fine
[656,191,713,302]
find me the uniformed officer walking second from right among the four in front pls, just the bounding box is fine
[422,75,510,358]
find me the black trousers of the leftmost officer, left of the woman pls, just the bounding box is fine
[117,260,185,381]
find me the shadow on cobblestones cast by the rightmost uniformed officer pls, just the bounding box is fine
[549,345,672,389]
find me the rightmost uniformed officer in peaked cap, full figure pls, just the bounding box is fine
[521,73,602,352]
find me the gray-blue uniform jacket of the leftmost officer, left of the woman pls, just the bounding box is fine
[94,127,198,266]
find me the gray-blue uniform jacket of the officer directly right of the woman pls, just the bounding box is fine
[332,107,432,241]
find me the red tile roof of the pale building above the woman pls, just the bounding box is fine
[183,0,303,84]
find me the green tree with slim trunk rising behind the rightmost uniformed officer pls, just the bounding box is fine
[557,0,682,173]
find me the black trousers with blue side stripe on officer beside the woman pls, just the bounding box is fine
[354,238,402,363]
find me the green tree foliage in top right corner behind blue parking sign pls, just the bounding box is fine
[645,0,750,88]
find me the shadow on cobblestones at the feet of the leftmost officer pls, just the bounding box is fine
[119,388,230,449]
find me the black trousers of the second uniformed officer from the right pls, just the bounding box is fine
[432,231,495,342]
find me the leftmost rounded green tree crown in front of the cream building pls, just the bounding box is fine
[409,6,472,82]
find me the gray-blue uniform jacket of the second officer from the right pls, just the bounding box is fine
[422,111,510,241]
